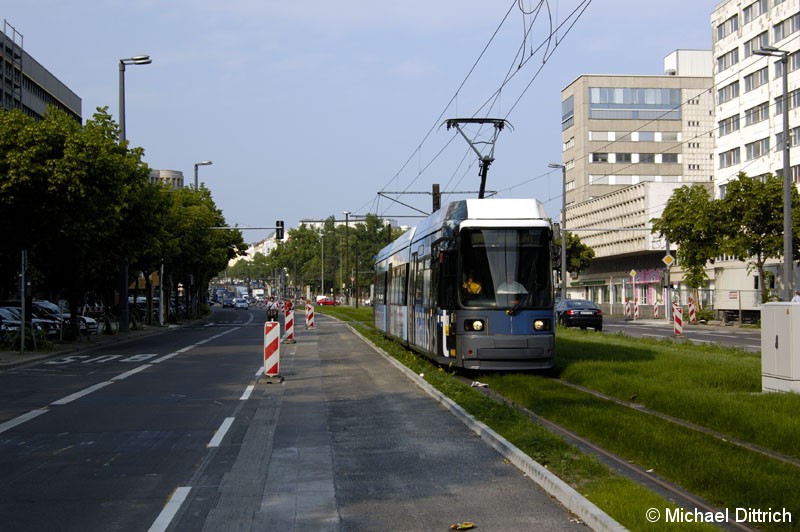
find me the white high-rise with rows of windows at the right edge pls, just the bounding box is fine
[708,0,800,309]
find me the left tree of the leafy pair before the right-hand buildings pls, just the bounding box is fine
[651,185,723,289]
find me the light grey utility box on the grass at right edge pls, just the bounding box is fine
[761,303,800,393]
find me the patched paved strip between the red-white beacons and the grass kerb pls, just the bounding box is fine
[169,317,621,532]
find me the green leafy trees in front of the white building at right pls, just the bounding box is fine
[652,173,800,301]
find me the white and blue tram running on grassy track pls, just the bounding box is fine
[373,199,555,370]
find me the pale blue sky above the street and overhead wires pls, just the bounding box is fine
[0,0,716,242]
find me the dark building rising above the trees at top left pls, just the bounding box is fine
[0,20,82,122]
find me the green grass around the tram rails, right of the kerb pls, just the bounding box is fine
[318,307,800,530]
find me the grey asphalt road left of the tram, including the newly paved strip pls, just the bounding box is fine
[0,309,600,532]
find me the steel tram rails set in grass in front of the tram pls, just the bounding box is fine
[455,375,760,532]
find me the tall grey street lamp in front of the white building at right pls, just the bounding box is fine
[753,46,794,301]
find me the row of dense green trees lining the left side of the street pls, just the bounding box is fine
[0,108,245,328]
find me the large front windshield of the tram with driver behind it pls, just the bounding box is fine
[459,228,553,309]
